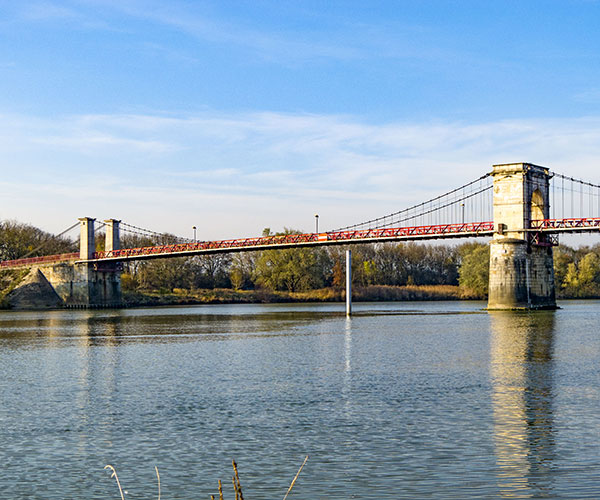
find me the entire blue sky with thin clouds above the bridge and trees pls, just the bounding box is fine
[0,0,600,239]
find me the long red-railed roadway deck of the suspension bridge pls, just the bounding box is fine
[0,218,600,269]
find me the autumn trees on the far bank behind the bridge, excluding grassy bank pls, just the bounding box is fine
[0,221,600,298]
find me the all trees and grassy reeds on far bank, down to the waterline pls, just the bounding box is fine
[0,221,600,305]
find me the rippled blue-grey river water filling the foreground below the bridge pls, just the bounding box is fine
[0,301,600,500]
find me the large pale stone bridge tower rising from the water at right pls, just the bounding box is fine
[488,163,556,309]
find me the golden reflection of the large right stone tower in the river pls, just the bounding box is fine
[490,311,555,498]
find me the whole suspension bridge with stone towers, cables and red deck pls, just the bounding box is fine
[0,163,600,308]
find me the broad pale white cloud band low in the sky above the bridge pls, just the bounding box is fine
[0,113,600,238]
